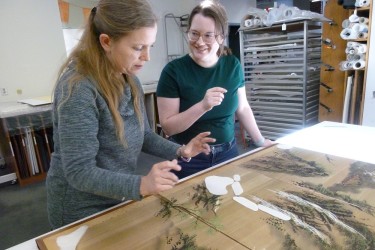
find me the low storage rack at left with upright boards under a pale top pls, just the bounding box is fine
[0,102,53,186]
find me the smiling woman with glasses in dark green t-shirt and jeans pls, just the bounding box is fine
[157,0,272,178]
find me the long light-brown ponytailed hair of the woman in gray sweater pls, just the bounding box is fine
[55,0,157,145]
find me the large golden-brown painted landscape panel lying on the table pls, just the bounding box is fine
[8,123,375,249]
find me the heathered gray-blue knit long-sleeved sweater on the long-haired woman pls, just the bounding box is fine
[46,70,179,228]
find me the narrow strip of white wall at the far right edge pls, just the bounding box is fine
[362,2,375,127]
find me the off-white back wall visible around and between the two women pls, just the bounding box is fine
[0,0,256,102]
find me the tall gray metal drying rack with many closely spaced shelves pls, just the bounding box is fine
[240,20,321,140]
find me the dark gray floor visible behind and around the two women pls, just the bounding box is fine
[0,142,254,249]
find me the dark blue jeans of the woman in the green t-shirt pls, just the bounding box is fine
[173,139,239,179]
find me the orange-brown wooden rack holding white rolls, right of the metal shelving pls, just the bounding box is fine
[319,0,372,124]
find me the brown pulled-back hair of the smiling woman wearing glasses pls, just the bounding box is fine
[187,0,231,56]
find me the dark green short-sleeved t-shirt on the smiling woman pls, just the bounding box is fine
[156,55,244,144]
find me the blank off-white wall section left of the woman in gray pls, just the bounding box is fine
[0,0,66,102]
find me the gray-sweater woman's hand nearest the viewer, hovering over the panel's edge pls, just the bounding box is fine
[140,160,181,196]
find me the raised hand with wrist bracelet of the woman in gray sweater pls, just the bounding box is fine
[180,132,216,158]
